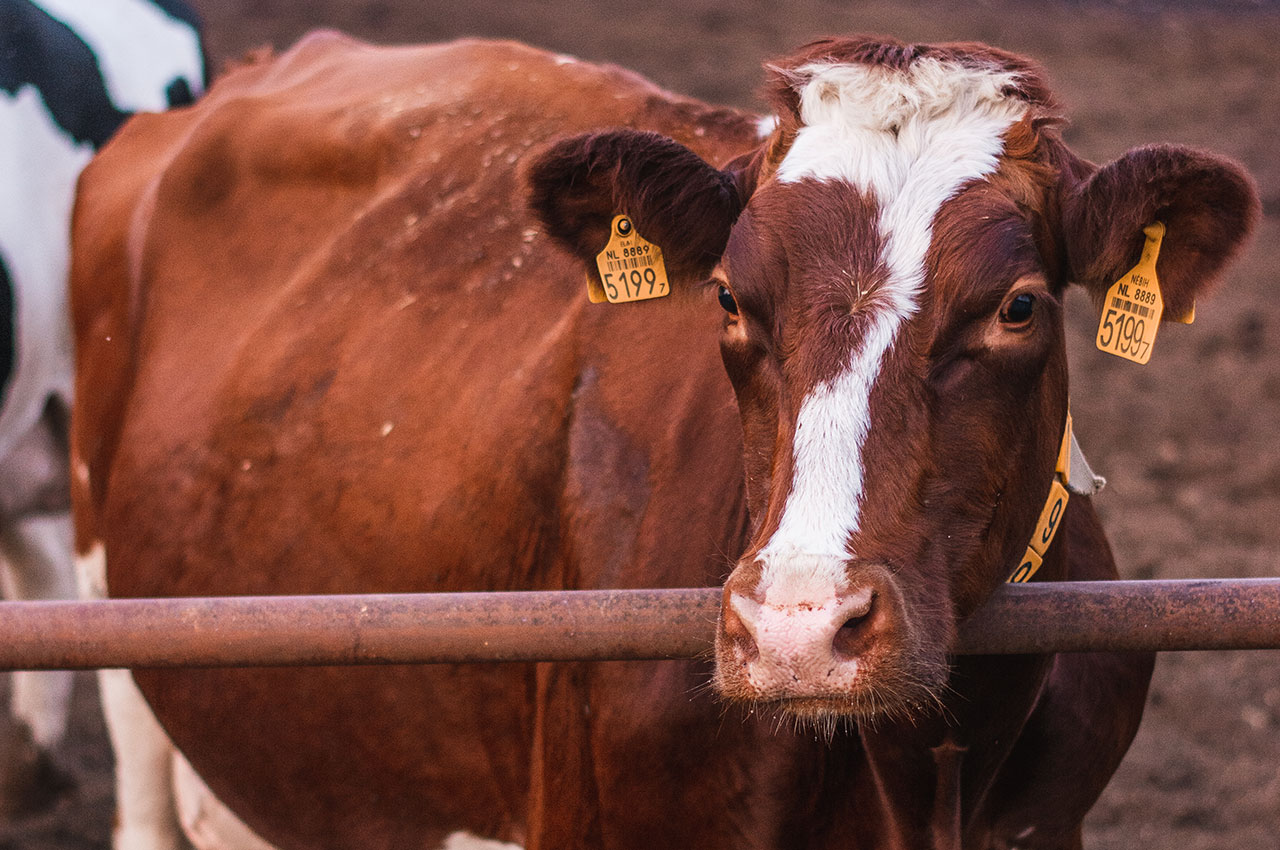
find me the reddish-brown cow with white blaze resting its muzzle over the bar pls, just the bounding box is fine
[64,33,1258,850]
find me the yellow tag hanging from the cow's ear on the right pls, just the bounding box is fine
[1097,221,1165,364]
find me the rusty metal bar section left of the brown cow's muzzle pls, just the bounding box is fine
[0,589,719,670]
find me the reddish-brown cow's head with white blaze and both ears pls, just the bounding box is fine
[529,38,1257,718]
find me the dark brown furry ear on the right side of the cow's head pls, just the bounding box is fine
[1062,145,1258,319]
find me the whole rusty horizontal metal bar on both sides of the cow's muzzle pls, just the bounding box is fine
[0,579,1280,670]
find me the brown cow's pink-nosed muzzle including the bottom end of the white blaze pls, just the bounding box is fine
[716,556,946,717]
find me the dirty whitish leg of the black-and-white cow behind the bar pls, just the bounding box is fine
[0,402,76,815]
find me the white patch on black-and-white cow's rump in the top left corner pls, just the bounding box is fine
[36,0,205,113]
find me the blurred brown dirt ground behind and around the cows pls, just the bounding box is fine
[0,0,1280,850]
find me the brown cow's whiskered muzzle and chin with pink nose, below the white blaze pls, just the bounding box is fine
[714,568,950,731]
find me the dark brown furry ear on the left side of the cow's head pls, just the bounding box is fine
[525,129,744,283]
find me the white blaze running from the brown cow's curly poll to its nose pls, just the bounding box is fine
[759,58,1027,596]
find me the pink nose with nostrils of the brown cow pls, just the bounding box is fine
[722,585,878,696]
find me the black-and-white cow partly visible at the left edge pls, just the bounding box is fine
[0,0,206,814]
